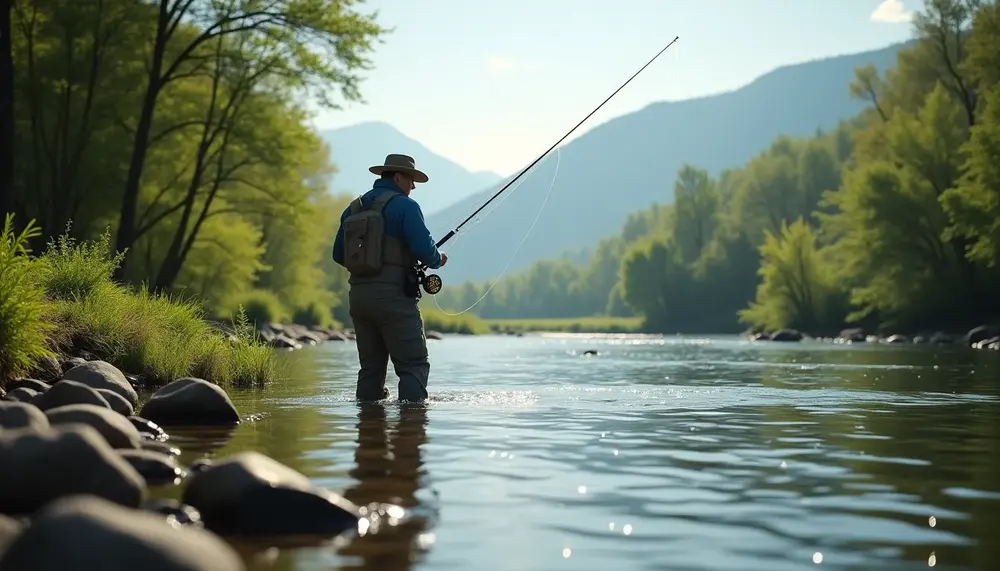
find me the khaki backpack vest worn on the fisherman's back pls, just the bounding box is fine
[343,191,416,283]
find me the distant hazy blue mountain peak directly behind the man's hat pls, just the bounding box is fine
[319,122,501,216]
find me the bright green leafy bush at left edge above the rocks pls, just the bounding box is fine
[0,214,55,385]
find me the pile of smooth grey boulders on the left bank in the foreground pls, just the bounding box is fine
[0,358,401,571]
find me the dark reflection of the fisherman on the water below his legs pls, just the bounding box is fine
[338,403,429,570]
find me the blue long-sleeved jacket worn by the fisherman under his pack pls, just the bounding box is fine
[333,178,441,269]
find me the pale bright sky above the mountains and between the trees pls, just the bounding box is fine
[306,0,923,175]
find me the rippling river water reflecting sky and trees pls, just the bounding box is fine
[156,336,1000,571]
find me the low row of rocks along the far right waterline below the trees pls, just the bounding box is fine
[747,325,1000,351]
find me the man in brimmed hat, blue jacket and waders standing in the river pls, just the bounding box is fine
[333,154,448,401]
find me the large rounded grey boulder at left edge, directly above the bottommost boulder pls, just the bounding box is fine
[0,425,147,512]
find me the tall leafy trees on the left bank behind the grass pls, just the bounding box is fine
[11,0,386,336]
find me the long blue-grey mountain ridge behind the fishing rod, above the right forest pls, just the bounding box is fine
[428,39,907,284]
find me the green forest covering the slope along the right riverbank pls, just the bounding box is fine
[437,0,1000,335]
